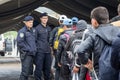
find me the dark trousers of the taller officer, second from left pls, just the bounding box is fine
[35,53,52,80]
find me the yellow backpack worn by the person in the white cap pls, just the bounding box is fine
[53,28,64,50]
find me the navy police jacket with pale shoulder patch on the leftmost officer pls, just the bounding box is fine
[17,26,36,55]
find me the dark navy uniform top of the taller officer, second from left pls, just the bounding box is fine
[36,24,51,53]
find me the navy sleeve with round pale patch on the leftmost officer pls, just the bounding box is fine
[17,32,30,51]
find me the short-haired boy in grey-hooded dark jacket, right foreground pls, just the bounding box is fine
[75,6,119,80]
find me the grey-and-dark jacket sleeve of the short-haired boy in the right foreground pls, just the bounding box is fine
[75,36,94,64]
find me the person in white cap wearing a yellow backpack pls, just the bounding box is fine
[49,15,67,80]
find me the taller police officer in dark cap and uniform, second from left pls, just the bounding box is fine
[35,13,52,80]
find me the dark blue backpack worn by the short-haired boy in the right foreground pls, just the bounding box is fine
[98,35,118,80]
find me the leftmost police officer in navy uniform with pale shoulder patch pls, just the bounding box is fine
[17,16,36,80]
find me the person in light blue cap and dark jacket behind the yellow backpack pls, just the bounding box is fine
[57,19,73,80]
